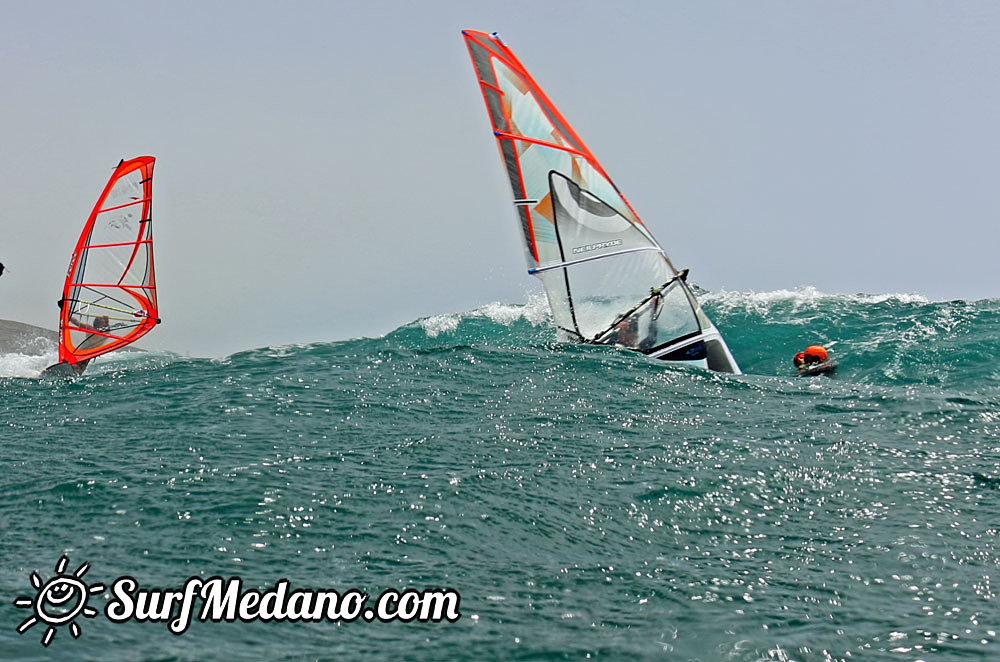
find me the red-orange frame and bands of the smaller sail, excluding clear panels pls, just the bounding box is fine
[59,156,160,365]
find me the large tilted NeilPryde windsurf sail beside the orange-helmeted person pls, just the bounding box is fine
[462,30,740,373]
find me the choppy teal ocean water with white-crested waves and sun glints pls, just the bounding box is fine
[0,289,1000,662]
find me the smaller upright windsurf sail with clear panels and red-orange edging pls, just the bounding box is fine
[51,156,160,374]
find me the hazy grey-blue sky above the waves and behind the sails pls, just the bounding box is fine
[0,0,1000,356]
